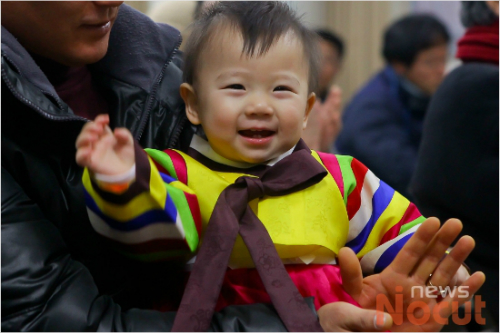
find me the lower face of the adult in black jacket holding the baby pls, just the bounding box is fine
[2,1,123,66]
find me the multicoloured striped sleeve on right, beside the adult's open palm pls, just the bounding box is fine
[336,155,425,274]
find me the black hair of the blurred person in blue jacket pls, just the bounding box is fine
[382,14,450,66]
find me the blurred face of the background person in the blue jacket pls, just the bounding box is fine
[403,44,448,95]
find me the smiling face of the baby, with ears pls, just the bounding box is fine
[181,28,315,163]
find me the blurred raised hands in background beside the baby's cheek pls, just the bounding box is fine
[302,86,342,152]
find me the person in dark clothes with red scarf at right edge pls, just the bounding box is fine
[410,1,499,331]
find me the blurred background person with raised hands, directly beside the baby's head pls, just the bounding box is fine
[303,29,344,152]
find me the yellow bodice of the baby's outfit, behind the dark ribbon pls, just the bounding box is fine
[179,151,349,268]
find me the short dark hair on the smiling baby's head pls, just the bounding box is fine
[184,1,321,92]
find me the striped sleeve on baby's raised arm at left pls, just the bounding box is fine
[83,144,201,261]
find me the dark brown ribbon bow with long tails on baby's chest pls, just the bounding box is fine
[172,149,327,332]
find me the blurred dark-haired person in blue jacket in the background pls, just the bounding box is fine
[336,14,450,198]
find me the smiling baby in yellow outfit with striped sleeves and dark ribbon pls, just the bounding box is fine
[76,2,474,330]
